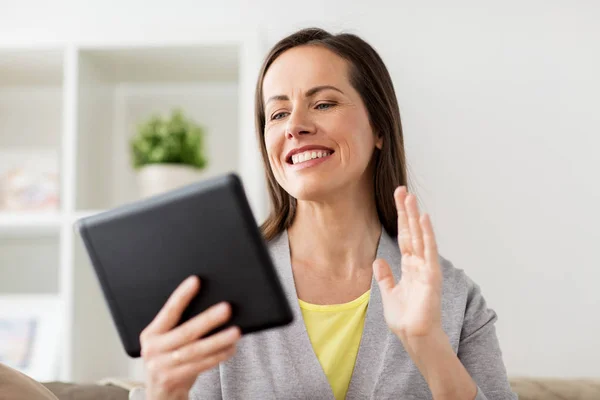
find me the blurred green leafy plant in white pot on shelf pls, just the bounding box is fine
[130,109,207,197]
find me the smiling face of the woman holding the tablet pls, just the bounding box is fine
[263,46,381,201]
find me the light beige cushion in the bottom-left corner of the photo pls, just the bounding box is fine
[0,364,58,400]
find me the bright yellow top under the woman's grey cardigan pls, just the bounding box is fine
[298,290,371,400]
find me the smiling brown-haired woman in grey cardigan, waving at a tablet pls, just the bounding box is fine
[141,29,516,400]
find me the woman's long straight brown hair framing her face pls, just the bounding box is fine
[255,28,408,241]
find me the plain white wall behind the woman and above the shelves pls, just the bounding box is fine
[0,0,600,377]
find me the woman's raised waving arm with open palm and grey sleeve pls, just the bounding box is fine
[373,187,515,400]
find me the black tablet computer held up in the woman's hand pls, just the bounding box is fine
[75,173,293,357]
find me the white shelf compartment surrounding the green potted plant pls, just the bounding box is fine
[75,45,241,209]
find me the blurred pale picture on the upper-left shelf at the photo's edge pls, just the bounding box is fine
[0,148,59,212]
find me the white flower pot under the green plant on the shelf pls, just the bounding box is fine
[137,164,202,198]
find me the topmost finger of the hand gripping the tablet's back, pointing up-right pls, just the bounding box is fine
[142,276,200,336]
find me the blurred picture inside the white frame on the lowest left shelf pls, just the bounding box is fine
[0,317,37,369]
